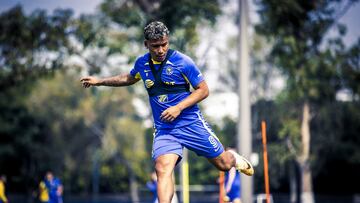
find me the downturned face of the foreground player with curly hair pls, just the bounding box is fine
[144,36,169,62]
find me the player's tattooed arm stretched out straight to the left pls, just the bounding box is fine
[80,73,140,88]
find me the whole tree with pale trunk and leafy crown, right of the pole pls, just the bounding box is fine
[256,0,355,203]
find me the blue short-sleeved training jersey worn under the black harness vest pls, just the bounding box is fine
[130,51,204,129]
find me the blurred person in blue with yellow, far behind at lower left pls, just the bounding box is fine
[44,171,64,203]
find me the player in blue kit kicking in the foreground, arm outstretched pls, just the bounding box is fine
[80,21,254,203]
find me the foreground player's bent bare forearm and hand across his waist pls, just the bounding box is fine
[160,81,209,122]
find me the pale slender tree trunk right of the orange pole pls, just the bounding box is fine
[298,101,315,203]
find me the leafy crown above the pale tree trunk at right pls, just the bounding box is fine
[256,1,358,102]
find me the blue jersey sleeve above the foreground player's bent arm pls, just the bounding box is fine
[182,57,204,88]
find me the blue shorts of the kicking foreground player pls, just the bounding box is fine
[152,119,224,160]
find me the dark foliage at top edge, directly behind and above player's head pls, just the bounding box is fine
[101,0,221,51]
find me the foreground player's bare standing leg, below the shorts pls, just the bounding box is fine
[155,154,179,203]
